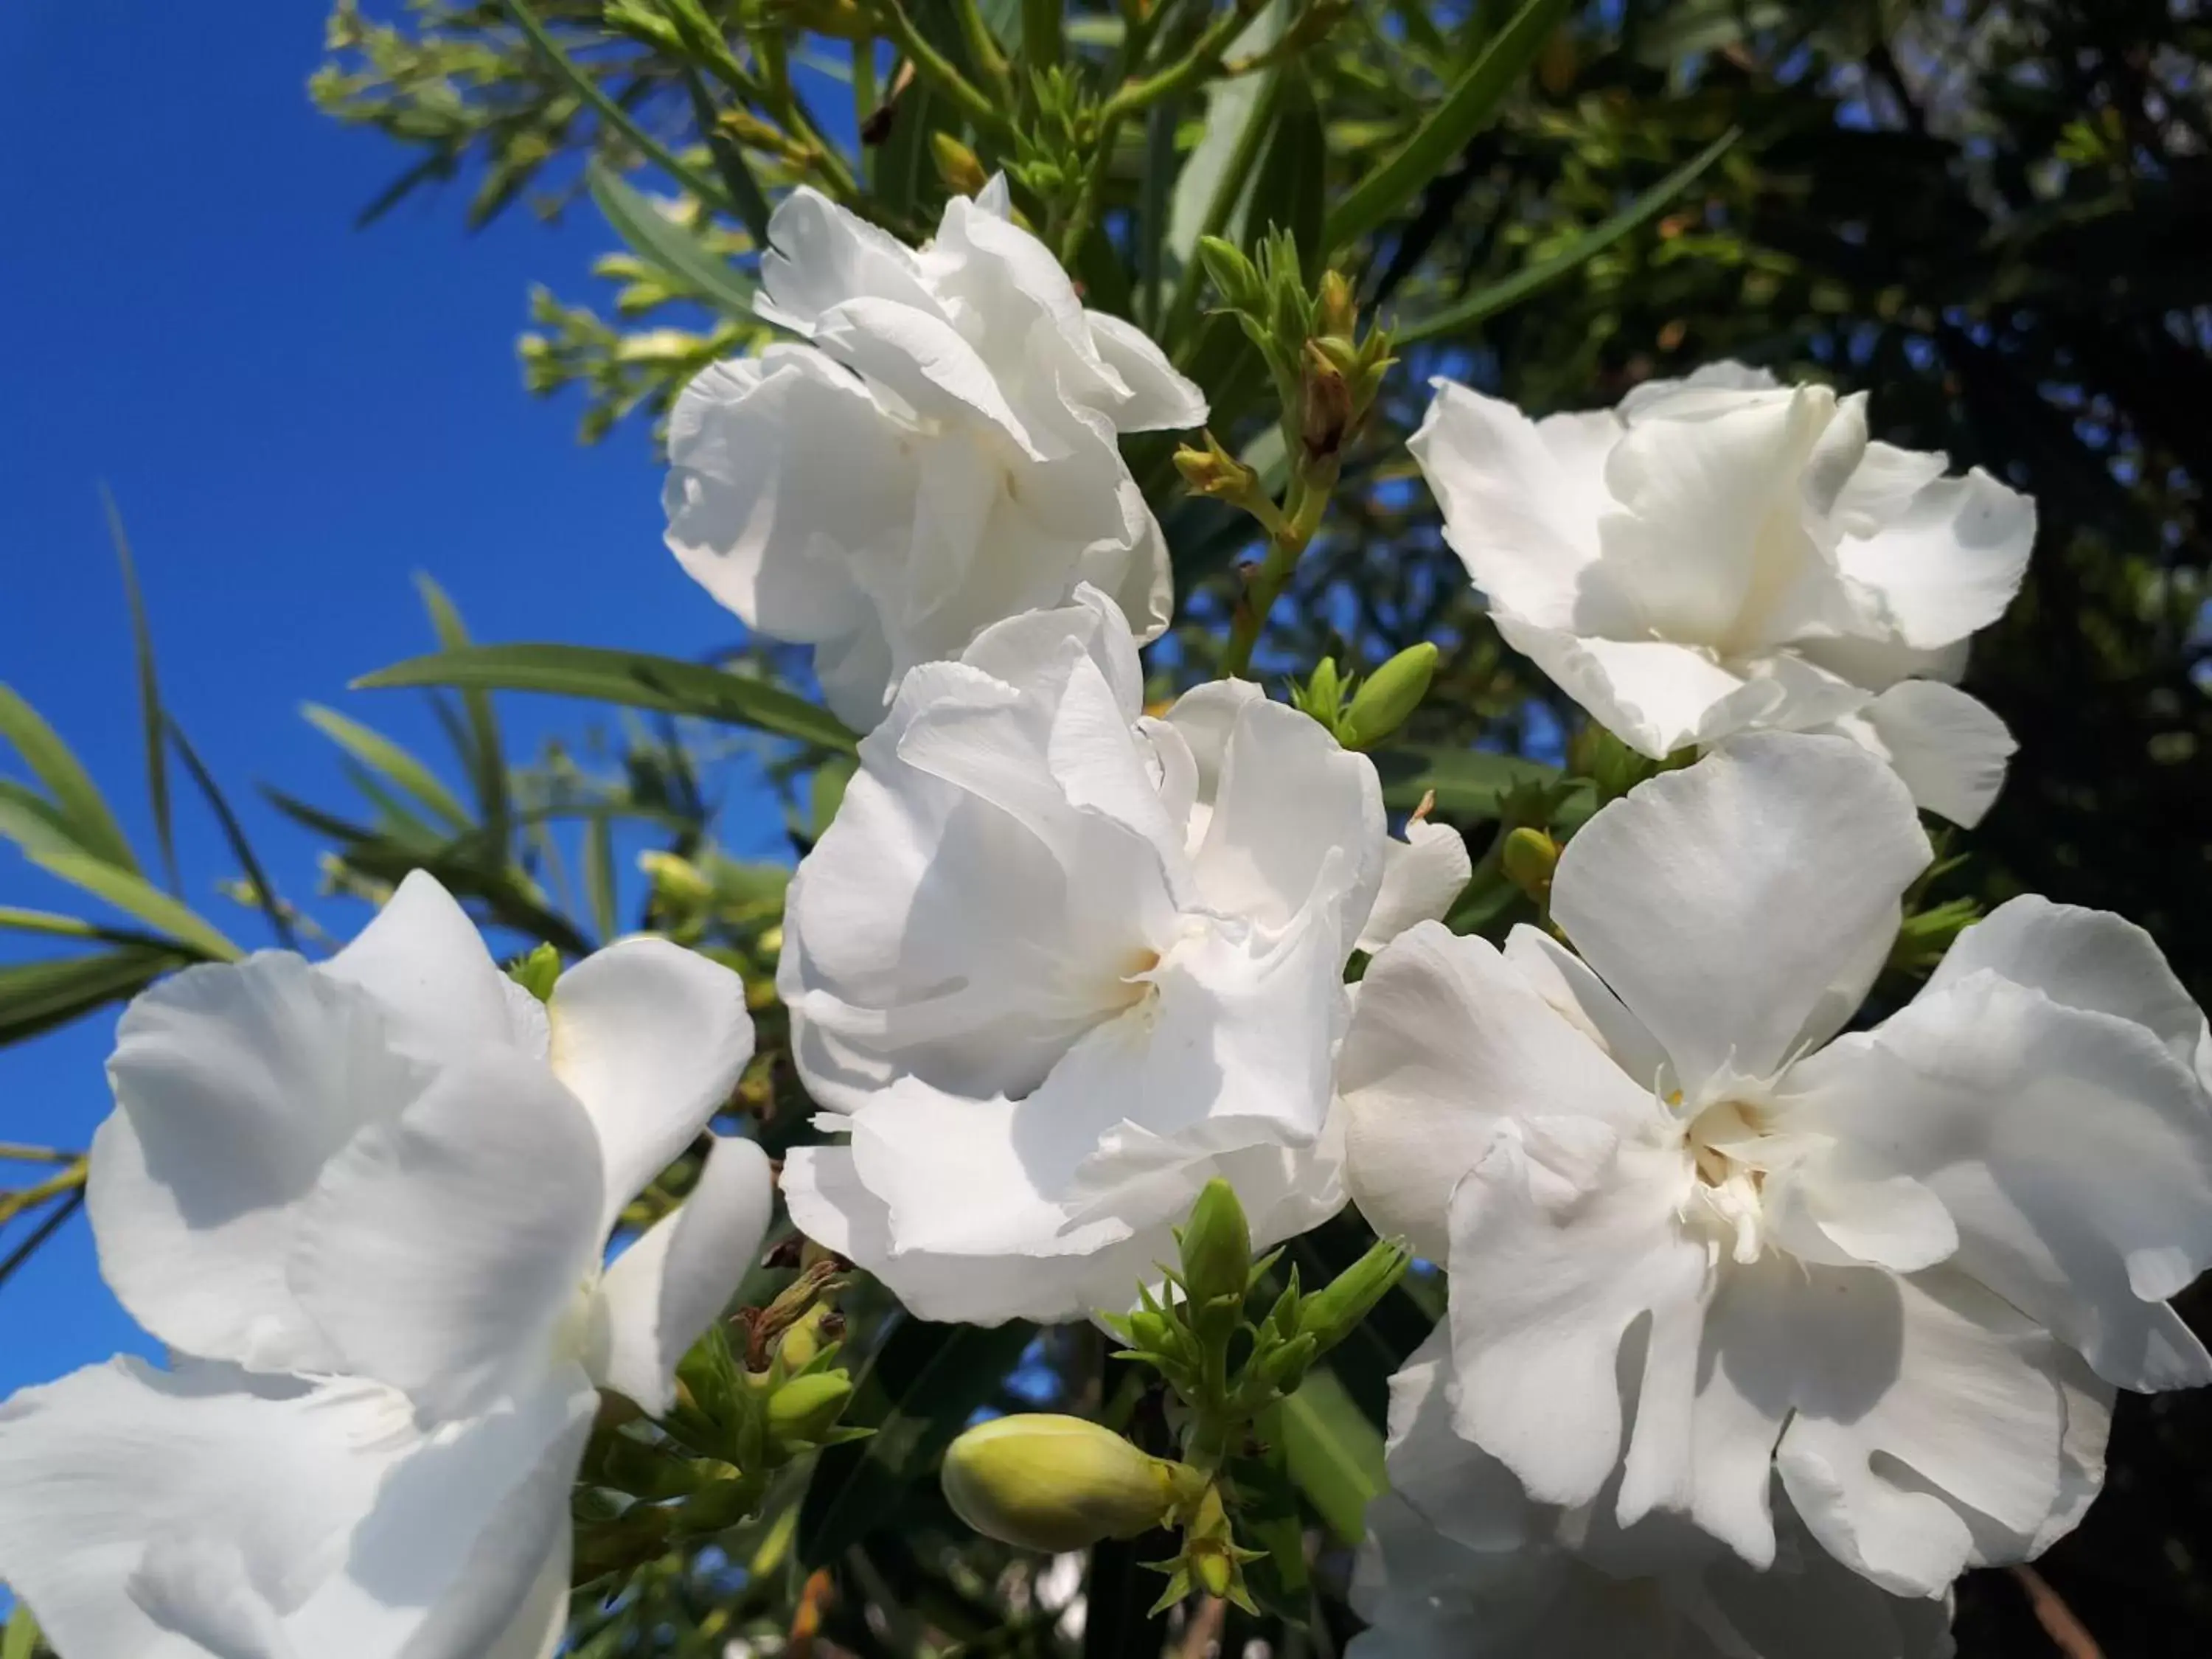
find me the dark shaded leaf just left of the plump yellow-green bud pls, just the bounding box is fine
[799,1318,1035,1568]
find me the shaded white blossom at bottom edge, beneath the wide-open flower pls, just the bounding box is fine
[1349,1327,1953,1659]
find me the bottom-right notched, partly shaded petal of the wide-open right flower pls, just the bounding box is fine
[1774,1267,2066,1595]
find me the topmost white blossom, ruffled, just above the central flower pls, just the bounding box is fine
[666,179,1206,730]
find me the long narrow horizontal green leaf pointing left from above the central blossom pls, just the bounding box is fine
[354,646,860,754]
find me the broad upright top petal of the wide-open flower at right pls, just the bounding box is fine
[1551,734,1929,1099]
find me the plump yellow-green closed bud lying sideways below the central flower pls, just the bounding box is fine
[940,1411,1203,1553]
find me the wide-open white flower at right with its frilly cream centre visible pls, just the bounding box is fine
[1338,734,2212,1595]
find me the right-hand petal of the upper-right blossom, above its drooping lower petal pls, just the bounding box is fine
[1836,469,2035,650]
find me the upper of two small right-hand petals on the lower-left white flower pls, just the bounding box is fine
[546,938,752,1239]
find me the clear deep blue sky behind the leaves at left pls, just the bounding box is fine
[0,0,796,1396]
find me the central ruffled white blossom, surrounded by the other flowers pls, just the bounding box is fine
[776,588,1467,1323]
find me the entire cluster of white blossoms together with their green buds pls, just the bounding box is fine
[0,181,2212,1659]
